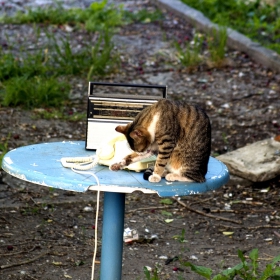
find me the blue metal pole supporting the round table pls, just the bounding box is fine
[100,192,125,280]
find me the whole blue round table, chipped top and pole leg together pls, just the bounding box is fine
[2,141,229,280]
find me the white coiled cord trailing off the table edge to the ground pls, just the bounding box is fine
[61,157,100,280]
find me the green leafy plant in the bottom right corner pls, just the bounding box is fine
[183,249,280,280]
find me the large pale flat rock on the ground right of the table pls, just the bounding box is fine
[217,137,280,182]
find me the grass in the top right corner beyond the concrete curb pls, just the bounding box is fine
[181,0,280,54]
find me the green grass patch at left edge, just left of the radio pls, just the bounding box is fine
[0,27,119,109]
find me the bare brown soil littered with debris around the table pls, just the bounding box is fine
[0,2,280,280]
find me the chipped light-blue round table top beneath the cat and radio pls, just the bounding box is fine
[2,141,229,197]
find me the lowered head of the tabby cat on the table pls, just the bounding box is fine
[116,123,151,153]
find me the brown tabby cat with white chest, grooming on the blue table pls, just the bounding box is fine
[110,99,211,182]
